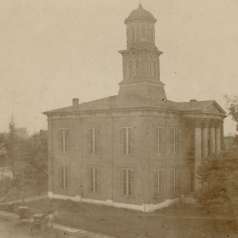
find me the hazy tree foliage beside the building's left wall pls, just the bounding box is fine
[0,131,48,198]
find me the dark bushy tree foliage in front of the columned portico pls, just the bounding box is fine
[197,149,238,218]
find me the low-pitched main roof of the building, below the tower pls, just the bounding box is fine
[44,95,226,116]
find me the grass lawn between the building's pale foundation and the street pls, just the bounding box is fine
[22,199,238,238]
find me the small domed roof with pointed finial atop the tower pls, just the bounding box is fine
[125,4,156,24]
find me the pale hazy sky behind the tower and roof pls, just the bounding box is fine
[0,0,238,134]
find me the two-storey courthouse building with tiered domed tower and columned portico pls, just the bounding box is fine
[45,5,225,211]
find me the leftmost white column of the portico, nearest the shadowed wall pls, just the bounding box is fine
[194,127,202,191]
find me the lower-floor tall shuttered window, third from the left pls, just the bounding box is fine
[122,169,134,196]
